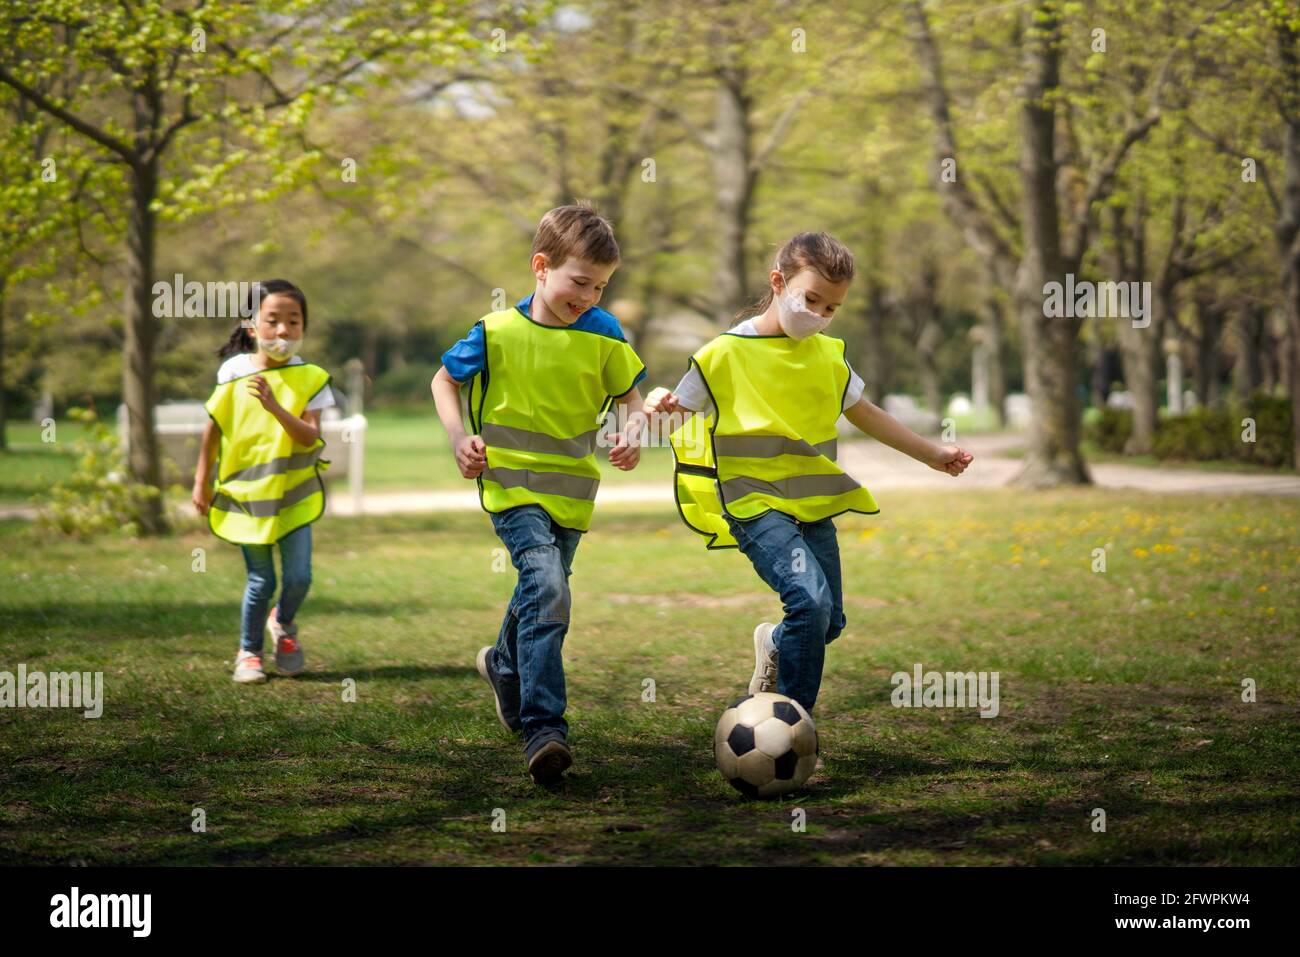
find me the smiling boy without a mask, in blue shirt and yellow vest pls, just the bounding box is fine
[432,203,645,784]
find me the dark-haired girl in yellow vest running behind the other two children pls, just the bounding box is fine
[192,280,334,684]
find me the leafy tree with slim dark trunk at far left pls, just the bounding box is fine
[0,0,478,533]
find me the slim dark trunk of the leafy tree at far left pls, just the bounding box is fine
[122,165,168,534]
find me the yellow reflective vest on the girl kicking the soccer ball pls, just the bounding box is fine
[670,333,880,549]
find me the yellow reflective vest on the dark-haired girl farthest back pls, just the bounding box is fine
[204,363,330,545]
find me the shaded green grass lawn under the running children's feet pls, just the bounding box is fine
[0,490,1300,865]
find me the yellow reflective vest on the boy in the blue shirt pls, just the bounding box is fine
[469,307,645,532]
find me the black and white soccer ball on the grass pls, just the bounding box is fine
[714,692,818,797]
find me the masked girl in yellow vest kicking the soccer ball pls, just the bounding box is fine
[645,233,971,713]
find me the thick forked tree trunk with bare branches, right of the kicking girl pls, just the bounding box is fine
[907,0,1222,486]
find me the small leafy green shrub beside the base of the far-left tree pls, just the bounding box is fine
[39,408,163,540]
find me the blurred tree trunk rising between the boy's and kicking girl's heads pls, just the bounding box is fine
[712,74,751,328]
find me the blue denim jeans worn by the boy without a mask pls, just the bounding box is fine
[491,505,582,745]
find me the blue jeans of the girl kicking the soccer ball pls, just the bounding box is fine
[727,511,846,713]
